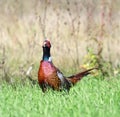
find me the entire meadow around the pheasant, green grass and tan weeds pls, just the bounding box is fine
[0,0,120,117]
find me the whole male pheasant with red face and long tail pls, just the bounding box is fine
[38,40,95,92]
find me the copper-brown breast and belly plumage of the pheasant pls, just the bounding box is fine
[38,61,60,91]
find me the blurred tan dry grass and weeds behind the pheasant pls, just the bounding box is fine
[0,0,120,83]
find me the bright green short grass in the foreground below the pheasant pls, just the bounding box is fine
[0,76,120,117]
